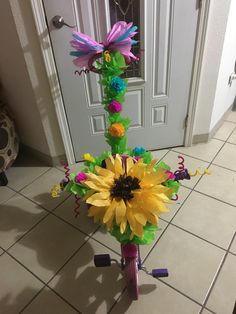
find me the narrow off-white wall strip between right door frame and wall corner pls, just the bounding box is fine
[193,0,231,135]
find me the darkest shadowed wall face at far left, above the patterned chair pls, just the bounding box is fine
[0,1,49,154]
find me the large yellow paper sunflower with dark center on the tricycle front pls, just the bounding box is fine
[83,155,173,237]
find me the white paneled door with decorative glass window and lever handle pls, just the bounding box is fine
[44,0,198,161]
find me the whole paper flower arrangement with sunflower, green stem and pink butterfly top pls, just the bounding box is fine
[52,21,208,244]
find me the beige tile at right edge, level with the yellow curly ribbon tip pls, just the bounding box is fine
[195,165,236,206]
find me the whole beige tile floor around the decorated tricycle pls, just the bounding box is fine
[0,112,236,314]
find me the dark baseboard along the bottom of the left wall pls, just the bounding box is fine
[20,143,66,167]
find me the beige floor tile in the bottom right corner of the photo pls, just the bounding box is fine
[206,254,236,314]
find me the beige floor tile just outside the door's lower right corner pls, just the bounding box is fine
[172,139,224,162]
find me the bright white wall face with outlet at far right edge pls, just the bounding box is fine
[210,0,236,130]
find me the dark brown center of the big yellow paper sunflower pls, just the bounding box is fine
[111,175,140,200]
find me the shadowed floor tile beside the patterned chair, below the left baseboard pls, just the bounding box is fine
[6,166,49,191]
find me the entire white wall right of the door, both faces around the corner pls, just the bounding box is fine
[193,0,236,135]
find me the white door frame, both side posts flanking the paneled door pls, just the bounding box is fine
[30,0,210,164]
